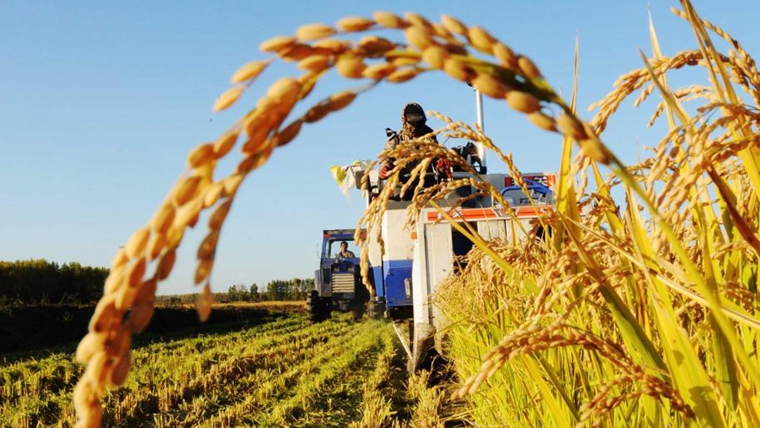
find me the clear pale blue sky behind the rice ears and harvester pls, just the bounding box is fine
[0,0,760,294]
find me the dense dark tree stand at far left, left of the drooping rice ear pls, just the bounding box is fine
[0,259,108,305]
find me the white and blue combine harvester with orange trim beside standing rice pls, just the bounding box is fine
[313,94,557,370]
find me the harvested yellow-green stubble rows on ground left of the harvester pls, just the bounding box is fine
[0,314,448,428]
